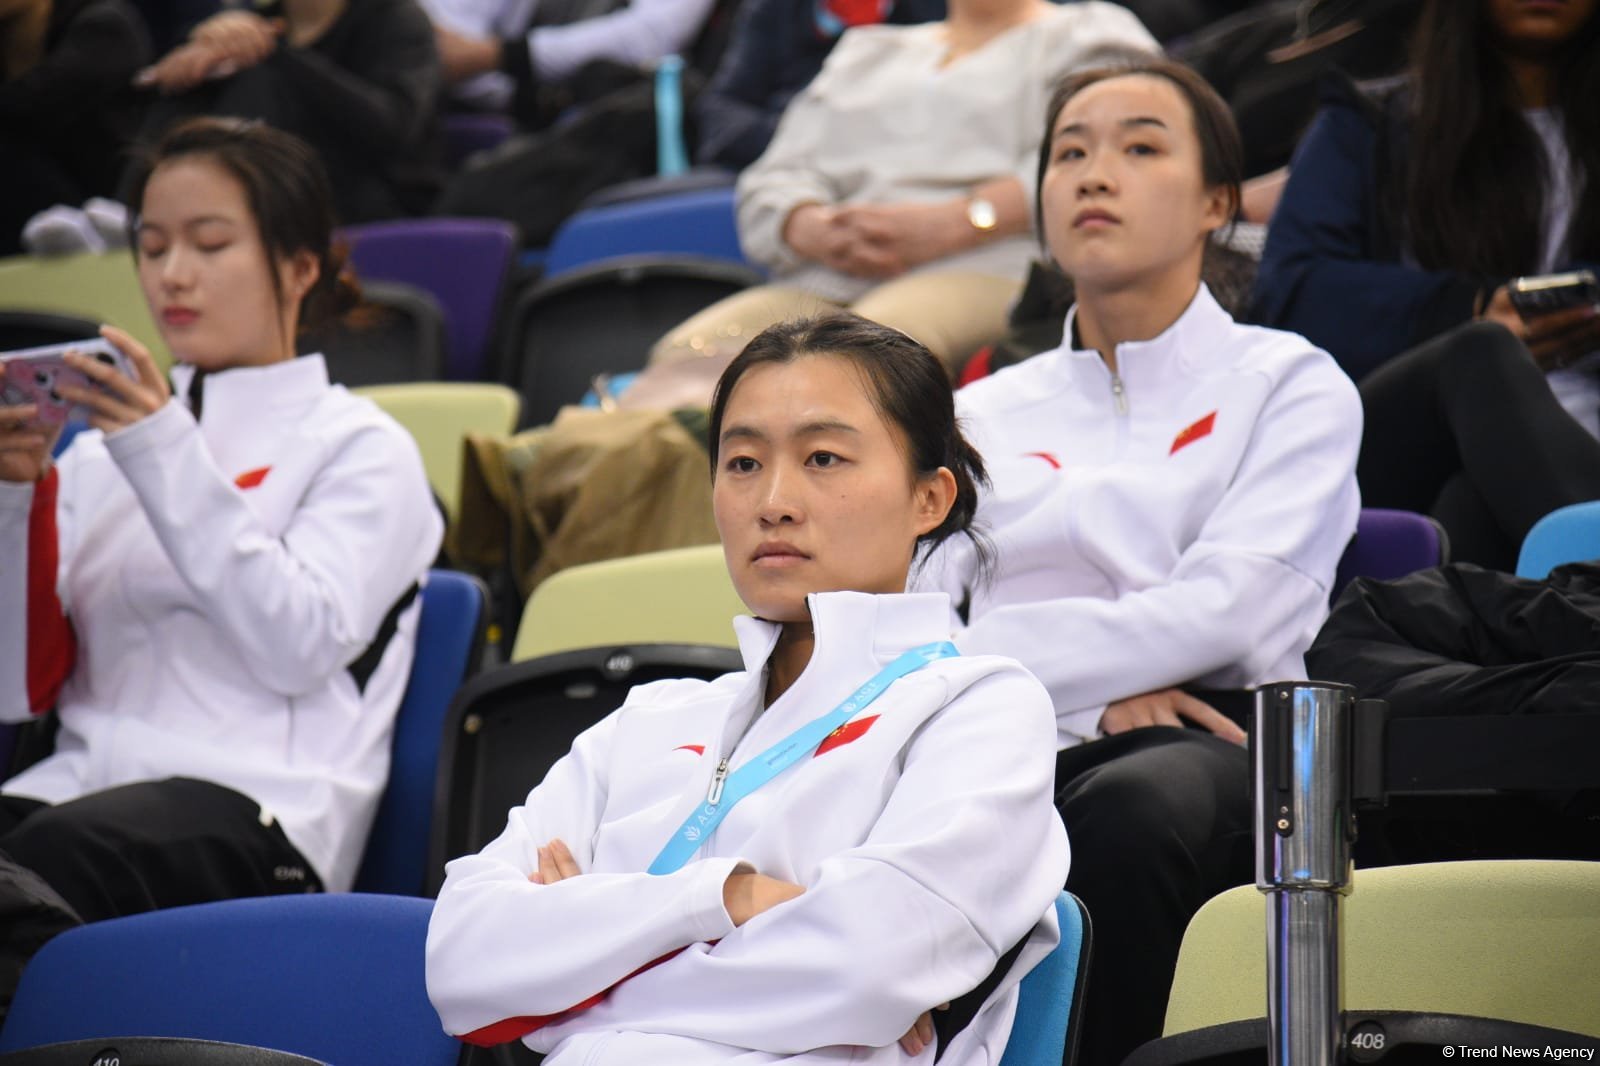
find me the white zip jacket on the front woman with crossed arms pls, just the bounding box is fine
[427,592,1067,1066]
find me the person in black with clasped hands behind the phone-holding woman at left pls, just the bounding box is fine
[139,0,440,222]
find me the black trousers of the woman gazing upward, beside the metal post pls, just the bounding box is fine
[1056,727,1253,1066]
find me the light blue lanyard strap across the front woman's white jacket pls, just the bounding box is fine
[648,640,960,874]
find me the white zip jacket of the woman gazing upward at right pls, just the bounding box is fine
[914,285,1362,747]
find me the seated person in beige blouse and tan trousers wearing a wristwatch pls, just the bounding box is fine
[651,0,1157,375]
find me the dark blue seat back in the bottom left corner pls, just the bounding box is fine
[0,893,461,1066]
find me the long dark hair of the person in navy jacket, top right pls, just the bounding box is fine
[1397,0,1600,283]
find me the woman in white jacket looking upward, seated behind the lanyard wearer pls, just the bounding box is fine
[918,61,1362,1066]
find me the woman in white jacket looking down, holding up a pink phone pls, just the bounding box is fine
[0,118,442,941]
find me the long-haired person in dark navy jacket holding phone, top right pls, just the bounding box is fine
[1251,0,1600,570]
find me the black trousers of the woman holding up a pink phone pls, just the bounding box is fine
[0,778,322,922]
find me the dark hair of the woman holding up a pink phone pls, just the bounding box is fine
[128,118,360,328]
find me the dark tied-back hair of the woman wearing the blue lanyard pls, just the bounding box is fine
[709,312,992,573]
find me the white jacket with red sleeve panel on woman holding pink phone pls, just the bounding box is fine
[0,355,443,890]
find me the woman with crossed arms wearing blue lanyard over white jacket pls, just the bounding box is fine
[427,315,1067,1066]
